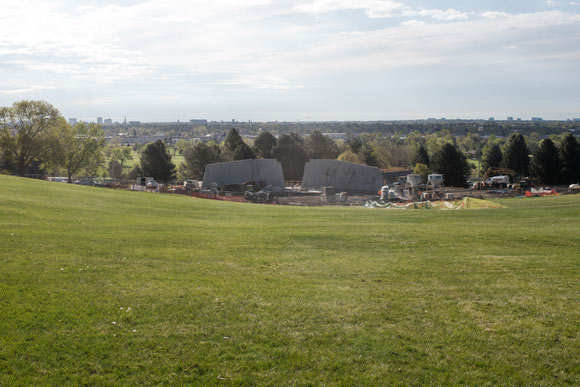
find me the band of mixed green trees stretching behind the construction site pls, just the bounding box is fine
[0,101,580,186]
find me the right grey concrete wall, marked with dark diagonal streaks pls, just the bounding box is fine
[302,159,383,193]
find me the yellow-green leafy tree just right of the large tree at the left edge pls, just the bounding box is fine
[53,122,105,183]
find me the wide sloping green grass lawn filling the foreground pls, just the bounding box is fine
[0,176,580,386]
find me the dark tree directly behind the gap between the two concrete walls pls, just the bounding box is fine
[273,133,308,180]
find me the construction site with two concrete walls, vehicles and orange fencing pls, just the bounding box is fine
[90,159,578,209]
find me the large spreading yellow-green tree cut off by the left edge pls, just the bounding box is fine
[0,100,64,176]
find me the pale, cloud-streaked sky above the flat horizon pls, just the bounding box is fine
[0,0,580,122]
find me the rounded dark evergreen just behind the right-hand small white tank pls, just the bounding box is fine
[431,143,470,187]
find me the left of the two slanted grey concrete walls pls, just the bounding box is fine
[202,159,284,189]
